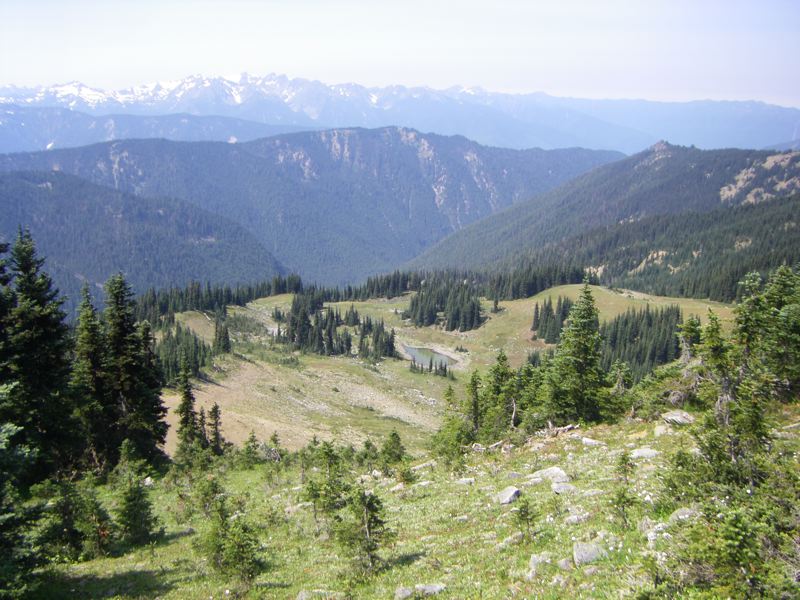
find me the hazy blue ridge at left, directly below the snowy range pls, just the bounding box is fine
[0,105,318,153]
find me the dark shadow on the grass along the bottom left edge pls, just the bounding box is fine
[28,569,176,600]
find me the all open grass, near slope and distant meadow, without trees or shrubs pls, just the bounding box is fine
[31,286,800,599]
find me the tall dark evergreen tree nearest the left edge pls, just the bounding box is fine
[0,231,75,476]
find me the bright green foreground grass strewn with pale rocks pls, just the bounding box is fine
[39,398,800,600]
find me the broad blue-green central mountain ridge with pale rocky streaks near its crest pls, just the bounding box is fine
[0,128,620,283]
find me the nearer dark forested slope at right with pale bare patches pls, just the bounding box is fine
[524,195,800,301]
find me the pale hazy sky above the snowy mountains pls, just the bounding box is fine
[0,0,800,106]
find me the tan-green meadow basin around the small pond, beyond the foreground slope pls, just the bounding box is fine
[158,285,732,451]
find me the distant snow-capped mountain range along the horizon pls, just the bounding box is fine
[0,74,800,153]
